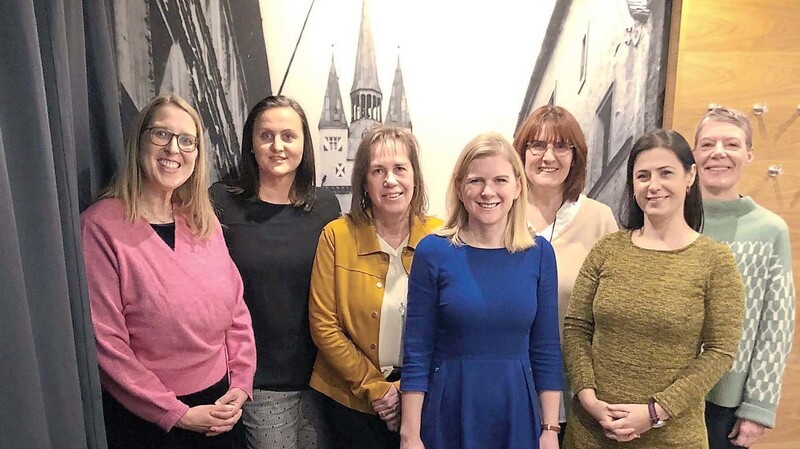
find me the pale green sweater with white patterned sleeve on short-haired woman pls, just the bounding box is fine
[703,197,795,427]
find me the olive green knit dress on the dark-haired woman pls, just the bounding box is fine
[563,231,744,449]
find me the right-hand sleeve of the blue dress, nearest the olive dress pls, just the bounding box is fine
[532,237,564,391]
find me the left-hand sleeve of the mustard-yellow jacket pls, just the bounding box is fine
[308,227,391,403]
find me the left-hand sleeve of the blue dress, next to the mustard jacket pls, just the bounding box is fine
[400,237,439,392]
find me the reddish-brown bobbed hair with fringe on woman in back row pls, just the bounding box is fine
[514,104,589,201]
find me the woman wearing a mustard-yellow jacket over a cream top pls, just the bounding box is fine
[309,125,441,449]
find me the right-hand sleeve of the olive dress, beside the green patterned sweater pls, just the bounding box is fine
[653,247,744,416]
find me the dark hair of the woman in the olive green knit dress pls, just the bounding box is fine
[620,129,703,232]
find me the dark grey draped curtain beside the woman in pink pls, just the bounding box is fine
[0,0,122,449]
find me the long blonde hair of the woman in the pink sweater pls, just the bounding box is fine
[101,95,215,239]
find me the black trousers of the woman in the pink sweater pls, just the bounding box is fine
[103,376,241,449]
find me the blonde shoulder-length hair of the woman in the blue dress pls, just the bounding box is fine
[436,132,535,253]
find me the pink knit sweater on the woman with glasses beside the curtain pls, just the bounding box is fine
[81,199,256,431]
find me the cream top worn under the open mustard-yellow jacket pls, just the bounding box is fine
[378,235,408,376]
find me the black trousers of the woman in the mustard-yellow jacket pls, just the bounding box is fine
[322,395,400,449]
